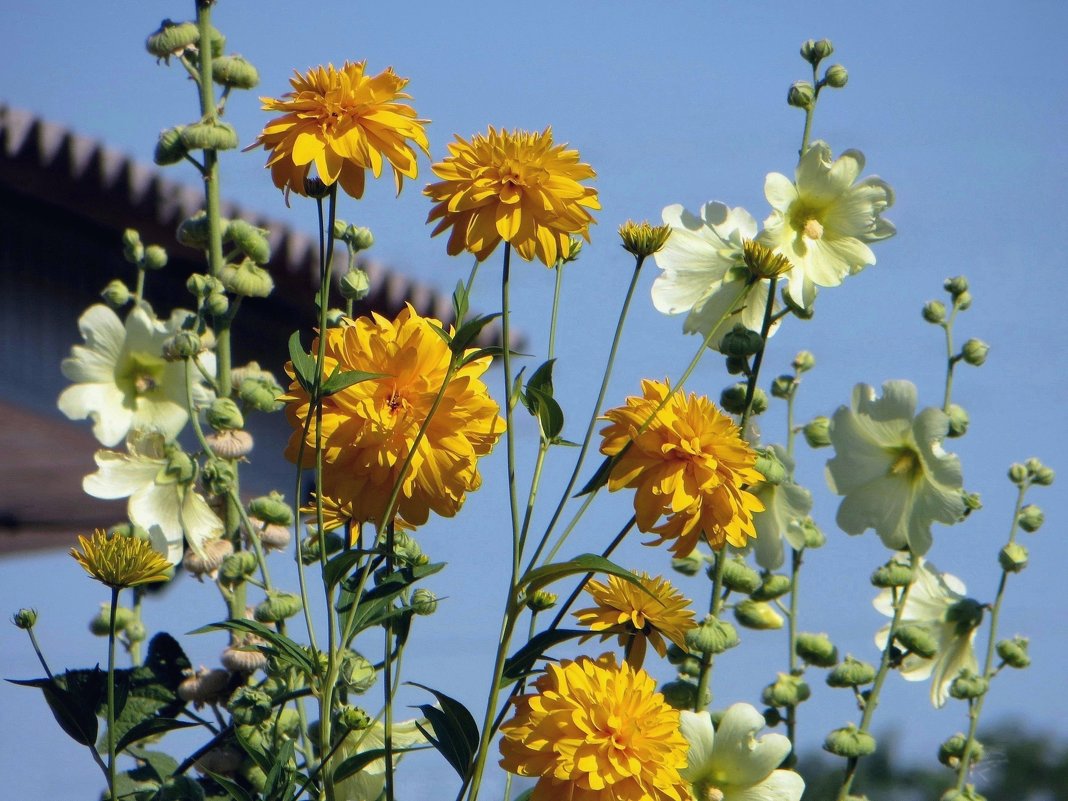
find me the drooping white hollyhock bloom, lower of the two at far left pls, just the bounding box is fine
[82,431,224,564]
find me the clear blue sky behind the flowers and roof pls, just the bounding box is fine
[0,0,1068,799]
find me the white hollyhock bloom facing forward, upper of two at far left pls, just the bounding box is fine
[59,303,215,446]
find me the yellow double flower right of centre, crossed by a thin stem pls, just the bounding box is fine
[600,379,764,556]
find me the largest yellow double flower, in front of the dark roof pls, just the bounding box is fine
[283,305,504,534]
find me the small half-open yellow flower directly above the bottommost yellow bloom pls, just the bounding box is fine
[575,572,694,669]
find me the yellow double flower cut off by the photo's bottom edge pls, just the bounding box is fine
[501,655,690,801]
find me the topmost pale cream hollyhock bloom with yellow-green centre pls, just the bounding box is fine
[759,142,896,308]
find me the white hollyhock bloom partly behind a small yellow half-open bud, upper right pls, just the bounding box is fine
[653,203,774,347]
